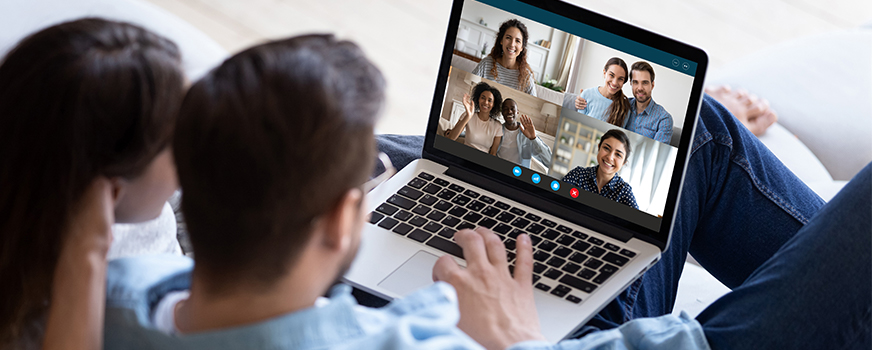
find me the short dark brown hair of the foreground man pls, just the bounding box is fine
[173,35,385,294]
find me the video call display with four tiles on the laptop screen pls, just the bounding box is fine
[435,0,696,231]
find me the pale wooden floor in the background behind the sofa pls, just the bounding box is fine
[147,0,872,134]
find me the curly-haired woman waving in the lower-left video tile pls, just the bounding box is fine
[446,82,503,155]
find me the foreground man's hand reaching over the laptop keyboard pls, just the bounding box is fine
[433,227,545,350]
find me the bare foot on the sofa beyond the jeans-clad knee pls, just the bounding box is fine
[705,85,778,136]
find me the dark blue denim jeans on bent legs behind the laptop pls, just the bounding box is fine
[379,96,872,349]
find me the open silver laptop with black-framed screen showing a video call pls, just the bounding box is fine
[343,0,708,341]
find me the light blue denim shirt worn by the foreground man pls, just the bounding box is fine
[104,255,708,350]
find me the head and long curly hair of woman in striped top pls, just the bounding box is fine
[490,19,531,90]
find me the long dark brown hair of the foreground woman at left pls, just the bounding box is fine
[0,18,184,348]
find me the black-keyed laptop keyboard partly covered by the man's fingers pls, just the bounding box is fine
[369,172,636,304]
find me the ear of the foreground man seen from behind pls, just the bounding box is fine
[322,188,363,251]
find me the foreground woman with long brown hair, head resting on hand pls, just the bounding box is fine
[0,19,184,349]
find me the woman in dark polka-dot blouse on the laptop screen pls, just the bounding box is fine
[563,129,639,209]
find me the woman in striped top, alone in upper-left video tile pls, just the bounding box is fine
[472,19,536,96]
